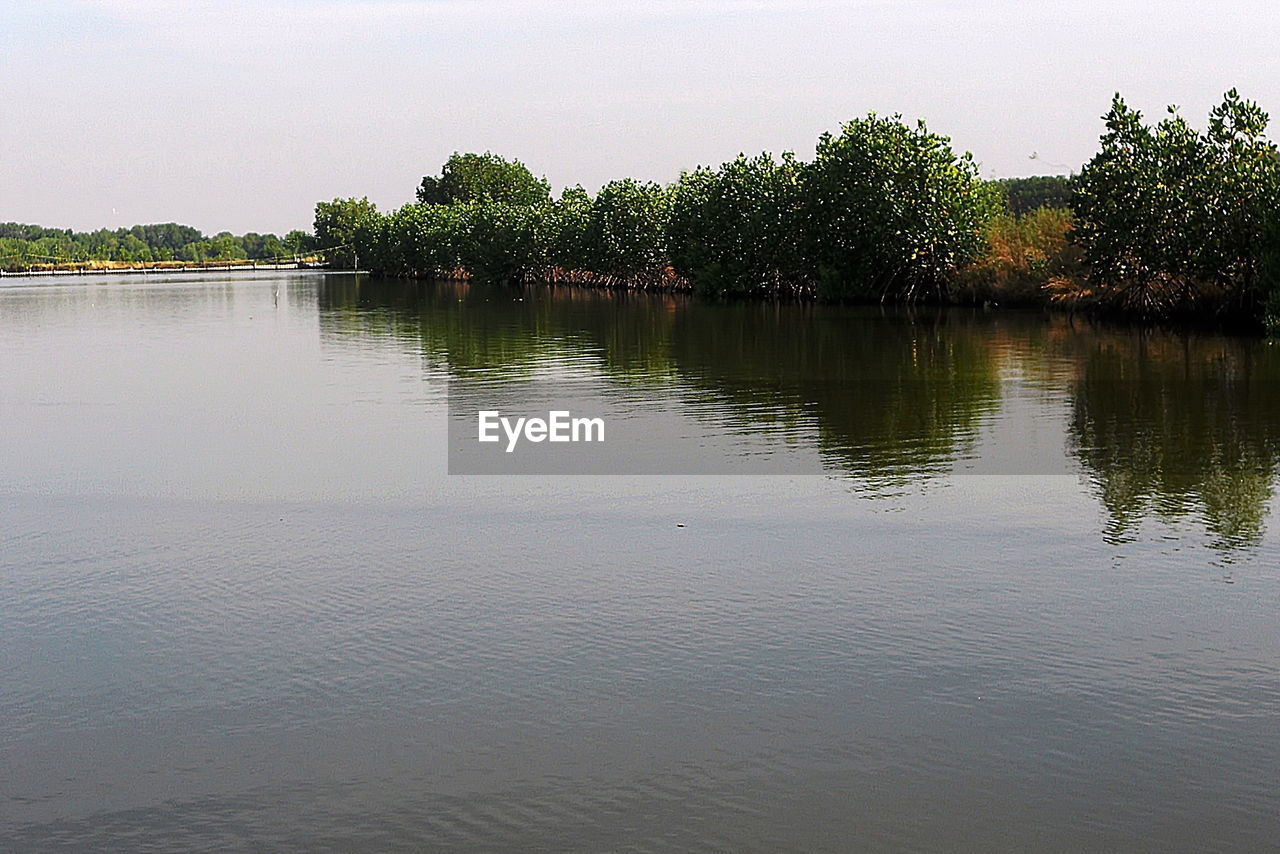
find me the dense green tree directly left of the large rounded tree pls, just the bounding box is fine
[667,154,805,294]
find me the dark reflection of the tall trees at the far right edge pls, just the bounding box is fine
[1070,333,1280,548]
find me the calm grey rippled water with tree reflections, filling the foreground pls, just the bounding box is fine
[0,275,1280,851]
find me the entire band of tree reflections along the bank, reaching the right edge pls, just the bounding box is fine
[320,278,1280,548]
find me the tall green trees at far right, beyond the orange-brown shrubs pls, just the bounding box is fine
[1075,90,1280,315]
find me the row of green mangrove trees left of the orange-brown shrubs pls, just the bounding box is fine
[353,124,1001,298]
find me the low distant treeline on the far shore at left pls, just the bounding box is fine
[0,223,315,268]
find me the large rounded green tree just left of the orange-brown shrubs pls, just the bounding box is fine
[804,114,1000,300]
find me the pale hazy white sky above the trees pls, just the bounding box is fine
[0,0,1280,233]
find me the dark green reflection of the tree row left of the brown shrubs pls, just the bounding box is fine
[321,279,1000,483]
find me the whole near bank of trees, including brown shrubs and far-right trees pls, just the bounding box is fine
[315,91,1280,330]
